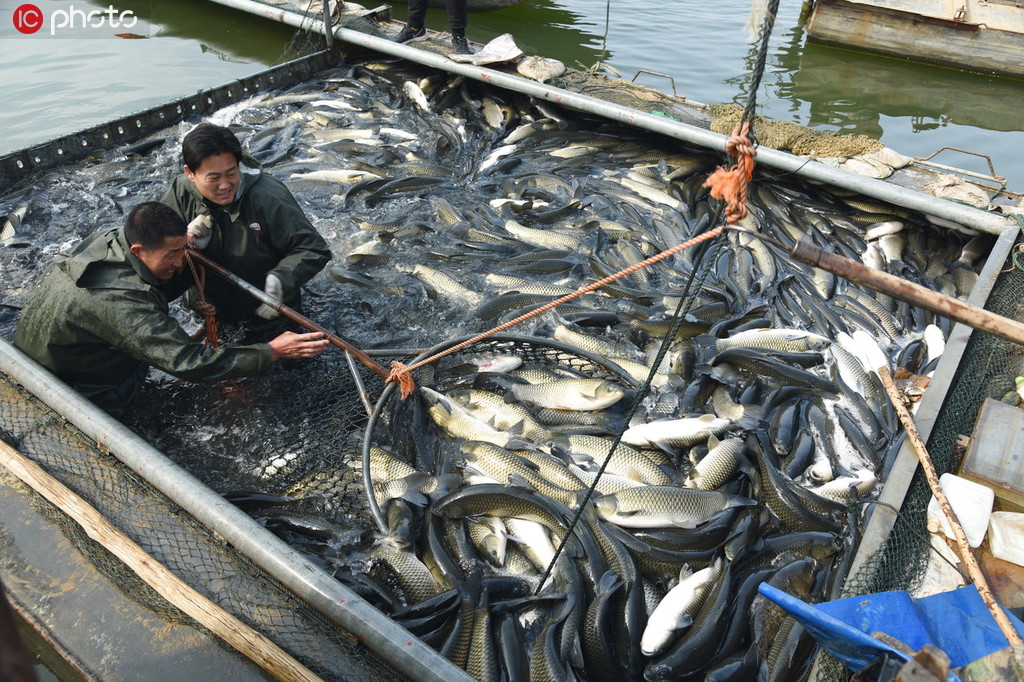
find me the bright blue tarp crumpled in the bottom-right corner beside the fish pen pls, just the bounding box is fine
[758,583,1024,681]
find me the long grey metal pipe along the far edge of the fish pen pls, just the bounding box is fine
[203,0,1017,235]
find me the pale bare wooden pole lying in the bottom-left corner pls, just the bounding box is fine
[0,440,321,682]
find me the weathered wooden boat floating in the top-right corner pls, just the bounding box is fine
[807,0,1024,78]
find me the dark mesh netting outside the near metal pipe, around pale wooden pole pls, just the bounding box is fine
[0,368,400,681]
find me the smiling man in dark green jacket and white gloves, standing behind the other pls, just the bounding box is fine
[162,123,331,323]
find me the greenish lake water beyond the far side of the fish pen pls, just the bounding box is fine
[0,0,1024,191]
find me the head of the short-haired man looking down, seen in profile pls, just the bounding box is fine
[125,202,185,280]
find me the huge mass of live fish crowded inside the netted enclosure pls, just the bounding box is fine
[0,59,989,680]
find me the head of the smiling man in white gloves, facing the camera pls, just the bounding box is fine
[181,123,242,206]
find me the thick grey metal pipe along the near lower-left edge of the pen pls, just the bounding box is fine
[0,339,472,682]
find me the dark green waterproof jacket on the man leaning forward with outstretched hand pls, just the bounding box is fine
[14,227,270,407]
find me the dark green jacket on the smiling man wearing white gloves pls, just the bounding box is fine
[162,166,331,322]
